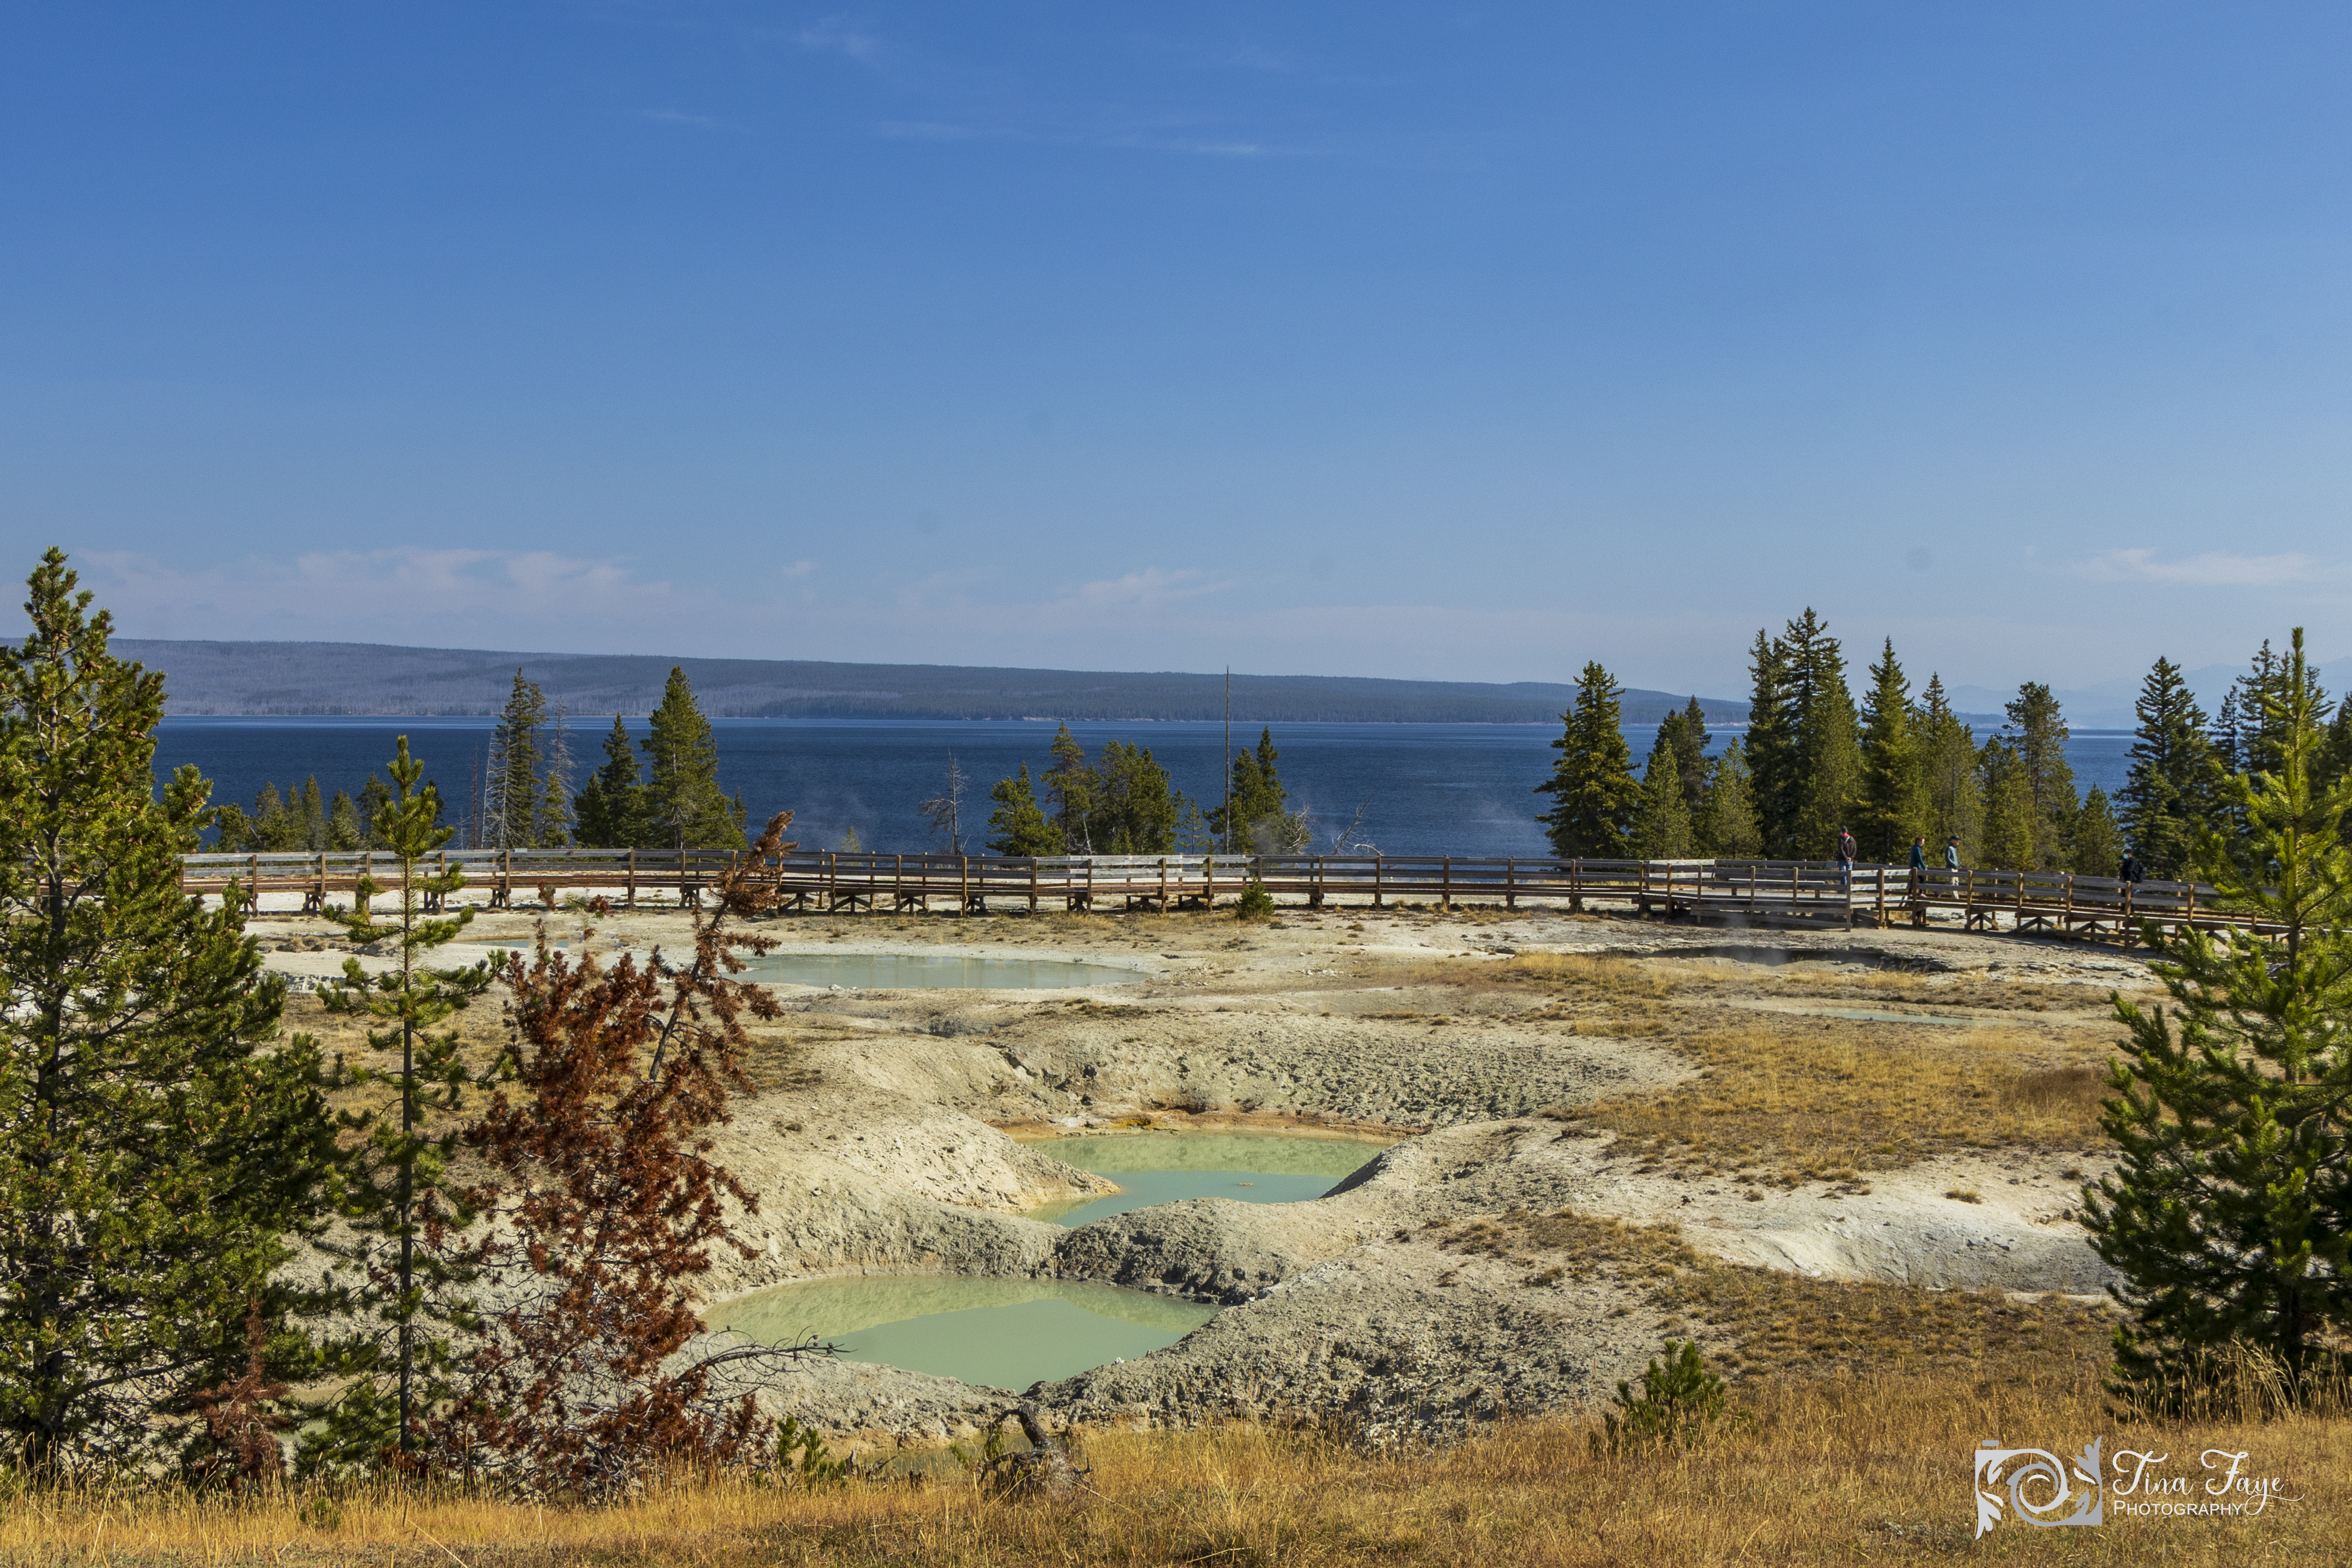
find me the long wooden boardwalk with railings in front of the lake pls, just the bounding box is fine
[181,849,2246,943]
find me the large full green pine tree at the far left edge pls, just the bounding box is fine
[0,550,334,1477]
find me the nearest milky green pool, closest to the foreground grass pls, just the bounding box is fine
[708,1277,1216,1389]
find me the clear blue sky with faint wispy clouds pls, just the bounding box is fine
[0,0,2352,694]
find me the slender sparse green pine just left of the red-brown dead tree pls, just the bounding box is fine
[303,736,491,1471]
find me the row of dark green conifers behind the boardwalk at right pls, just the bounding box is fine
[1536,609,2352,877]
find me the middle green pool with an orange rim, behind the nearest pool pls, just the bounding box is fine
[1030,1133,1383,1225]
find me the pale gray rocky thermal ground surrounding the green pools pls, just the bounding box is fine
[262,912,2145,1441]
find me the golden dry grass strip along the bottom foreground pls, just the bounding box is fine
[0,1373,2352,1568]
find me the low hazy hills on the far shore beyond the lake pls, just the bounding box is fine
[113,637,1747,724]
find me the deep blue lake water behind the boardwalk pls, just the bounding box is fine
[155,717,2131,855]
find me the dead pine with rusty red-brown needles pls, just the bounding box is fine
[433,813,828,1495]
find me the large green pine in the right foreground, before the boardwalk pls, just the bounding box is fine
[2084,627,2352,1406]
